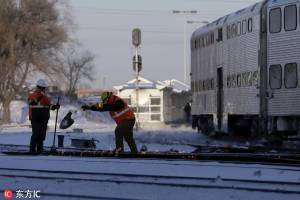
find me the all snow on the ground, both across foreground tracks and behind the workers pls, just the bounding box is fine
[0,102,300,200]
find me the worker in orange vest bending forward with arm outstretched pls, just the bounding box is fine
[82,91,138,153]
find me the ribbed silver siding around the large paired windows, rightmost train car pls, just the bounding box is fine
[268,9,300,116]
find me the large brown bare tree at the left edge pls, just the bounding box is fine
[0,0,68,123]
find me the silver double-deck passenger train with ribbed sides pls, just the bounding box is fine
[191,0,300,134]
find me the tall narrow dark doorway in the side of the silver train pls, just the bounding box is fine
[217,67,224,131]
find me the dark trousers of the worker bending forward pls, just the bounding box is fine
[115,119,137,153]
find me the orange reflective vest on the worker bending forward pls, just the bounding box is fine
[107,95,135,124]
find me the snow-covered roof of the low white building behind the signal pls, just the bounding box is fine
[114,76,190,93]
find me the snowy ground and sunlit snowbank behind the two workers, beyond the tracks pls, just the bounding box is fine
[0,101,212,152]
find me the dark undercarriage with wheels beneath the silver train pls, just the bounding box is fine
[192,114,300,139]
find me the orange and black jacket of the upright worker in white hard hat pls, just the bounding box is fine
[28,89,51,121]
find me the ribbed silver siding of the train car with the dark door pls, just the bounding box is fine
[191,3,262,115]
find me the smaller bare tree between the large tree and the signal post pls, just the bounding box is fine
[64,50,95,97]
